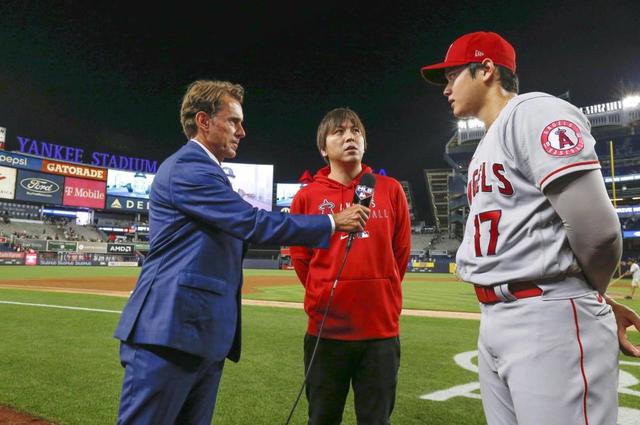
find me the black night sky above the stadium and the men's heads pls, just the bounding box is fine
[0,0,640,219]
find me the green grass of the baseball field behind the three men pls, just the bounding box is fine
[0,266,640,425]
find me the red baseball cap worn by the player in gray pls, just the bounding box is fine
[420,31,516,85]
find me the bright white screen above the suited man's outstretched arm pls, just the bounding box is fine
[222,162,273,211]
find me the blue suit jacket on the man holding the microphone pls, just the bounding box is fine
[115,142,331,361]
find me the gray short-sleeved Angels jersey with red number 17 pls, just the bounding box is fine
[456,93,600,285]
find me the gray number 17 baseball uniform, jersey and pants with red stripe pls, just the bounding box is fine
[456,93,618,425]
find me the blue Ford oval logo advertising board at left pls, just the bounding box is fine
[15,170,64,205]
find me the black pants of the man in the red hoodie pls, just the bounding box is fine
[304,334,400,425]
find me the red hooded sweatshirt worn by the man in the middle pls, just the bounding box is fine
[291,164,411,340]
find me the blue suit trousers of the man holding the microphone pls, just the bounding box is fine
[117,342,224,425]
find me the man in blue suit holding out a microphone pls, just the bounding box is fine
[115,80,369,425]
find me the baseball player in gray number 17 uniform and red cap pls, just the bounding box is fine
[422,32,640,425]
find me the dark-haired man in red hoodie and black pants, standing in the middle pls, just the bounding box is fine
[291,108,411,425]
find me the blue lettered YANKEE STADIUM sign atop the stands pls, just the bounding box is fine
[17,136,158,171]
